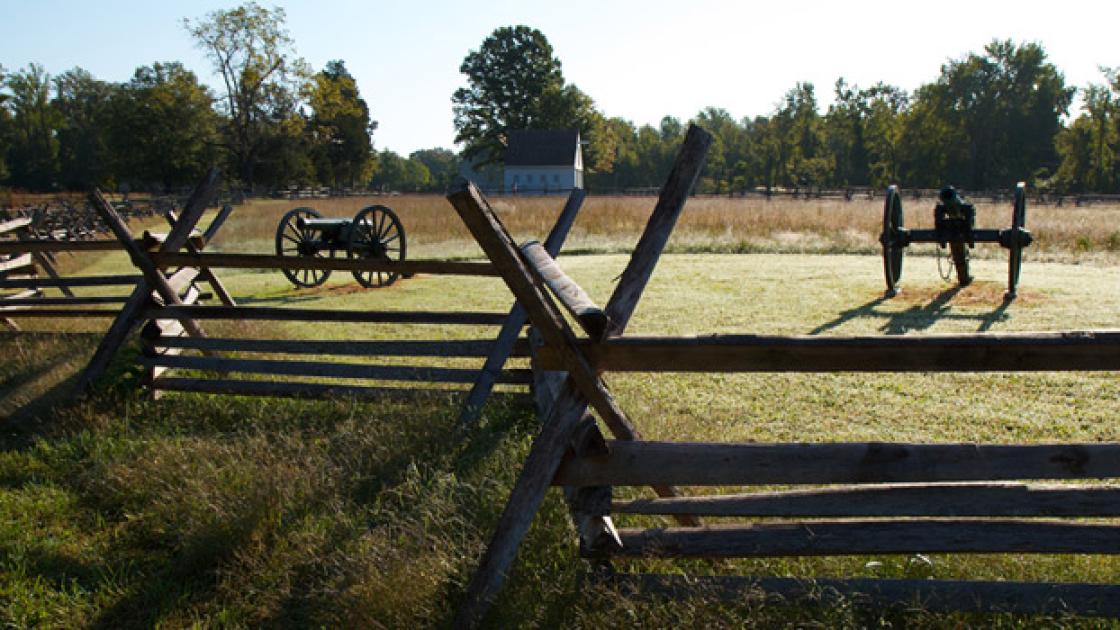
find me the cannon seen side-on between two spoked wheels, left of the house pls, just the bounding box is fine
[277,205,405,288]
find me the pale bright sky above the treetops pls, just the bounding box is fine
[0,0,1120,155]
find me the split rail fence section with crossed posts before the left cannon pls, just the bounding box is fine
[64,170,584,424]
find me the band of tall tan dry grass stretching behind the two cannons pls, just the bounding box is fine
[213,195,1120,262]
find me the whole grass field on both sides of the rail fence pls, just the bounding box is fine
[0,197,1120,628]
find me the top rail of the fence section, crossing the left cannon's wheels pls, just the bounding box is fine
[146,252,497,276]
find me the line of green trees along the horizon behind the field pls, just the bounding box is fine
[0,2,1120,193]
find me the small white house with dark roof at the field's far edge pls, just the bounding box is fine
[505,129,584,195]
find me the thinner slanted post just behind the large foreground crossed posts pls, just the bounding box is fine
[459,188,586,426]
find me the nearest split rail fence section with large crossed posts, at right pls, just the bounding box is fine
[448,127,1120,627]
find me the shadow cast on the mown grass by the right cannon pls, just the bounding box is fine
[809,286,1014,335]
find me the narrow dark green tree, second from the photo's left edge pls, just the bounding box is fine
[52,67,118,191]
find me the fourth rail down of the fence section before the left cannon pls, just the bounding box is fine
[146,356,531,385]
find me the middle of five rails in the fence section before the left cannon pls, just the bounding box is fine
[158,337,528,356]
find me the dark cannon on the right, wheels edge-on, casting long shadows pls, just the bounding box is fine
[879,182,1033,299]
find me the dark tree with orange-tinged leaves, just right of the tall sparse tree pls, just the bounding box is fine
[307,61,377,187]
